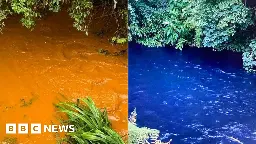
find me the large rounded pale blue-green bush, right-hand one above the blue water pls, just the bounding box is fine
[184,0,253,49]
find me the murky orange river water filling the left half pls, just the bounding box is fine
[0,9,128,144]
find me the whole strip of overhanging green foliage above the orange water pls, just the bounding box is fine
[0,0,128,43]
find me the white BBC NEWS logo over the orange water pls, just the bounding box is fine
[6,123,75,134]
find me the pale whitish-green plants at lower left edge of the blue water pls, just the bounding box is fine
[128,109,172,144]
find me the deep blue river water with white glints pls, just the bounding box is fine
[129,44,256,144]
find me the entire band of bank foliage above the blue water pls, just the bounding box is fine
[128,0,256,72]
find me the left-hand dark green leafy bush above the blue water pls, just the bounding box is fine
[128,0,189,47]
